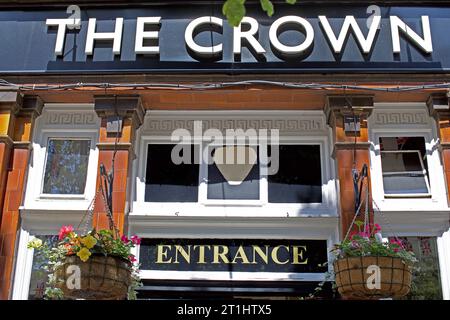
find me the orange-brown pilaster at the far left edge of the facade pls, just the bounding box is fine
[0,91,43,299]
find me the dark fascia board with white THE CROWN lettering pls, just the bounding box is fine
[0,4,450,74]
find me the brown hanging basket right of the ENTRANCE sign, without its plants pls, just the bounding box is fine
[334,256,412,299]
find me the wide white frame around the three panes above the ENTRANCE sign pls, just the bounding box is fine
[130,111,338,217]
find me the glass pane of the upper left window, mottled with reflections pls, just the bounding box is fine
[43,139,91,194]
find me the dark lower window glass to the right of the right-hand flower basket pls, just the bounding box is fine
[394,237,442,300]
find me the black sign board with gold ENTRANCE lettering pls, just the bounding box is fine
[139,239,328,273]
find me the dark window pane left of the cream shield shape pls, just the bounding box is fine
[145,144,199,202]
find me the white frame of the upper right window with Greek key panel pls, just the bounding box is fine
[368,102,450,236]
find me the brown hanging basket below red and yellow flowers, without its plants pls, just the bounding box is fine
[55,254,131,300]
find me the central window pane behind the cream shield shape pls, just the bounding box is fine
[207,148,260,200]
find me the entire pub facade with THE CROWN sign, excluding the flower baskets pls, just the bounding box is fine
[0,0,450,299]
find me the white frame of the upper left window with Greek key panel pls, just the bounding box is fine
[22,104,100,212]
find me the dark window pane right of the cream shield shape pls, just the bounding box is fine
[268,145,322,203]
